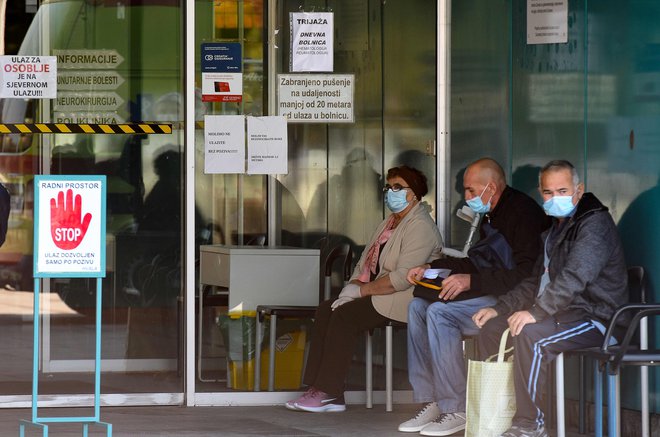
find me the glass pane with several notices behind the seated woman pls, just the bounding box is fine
[195,0,437,404]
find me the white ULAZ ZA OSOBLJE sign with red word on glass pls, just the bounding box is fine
[0,56,57,99]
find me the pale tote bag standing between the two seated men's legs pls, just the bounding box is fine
[465,329,516,437]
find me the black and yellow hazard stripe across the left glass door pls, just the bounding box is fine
[0,123,172,134]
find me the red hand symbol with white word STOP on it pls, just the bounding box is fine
[50,190,92,250]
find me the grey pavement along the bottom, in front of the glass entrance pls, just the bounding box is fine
[0,405,588,437]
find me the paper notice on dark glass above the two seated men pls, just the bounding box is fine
[527,0,568,44]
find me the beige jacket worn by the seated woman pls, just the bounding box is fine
[351,202,442,323]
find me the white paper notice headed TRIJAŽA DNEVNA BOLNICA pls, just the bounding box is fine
[289,12,334,72]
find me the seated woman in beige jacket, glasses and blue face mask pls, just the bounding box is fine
[286,166,442,412]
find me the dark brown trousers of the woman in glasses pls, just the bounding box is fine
[303,296,388,397]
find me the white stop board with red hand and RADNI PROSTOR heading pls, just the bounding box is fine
[35,176,105,277]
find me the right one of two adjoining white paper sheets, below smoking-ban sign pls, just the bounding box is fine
[248,116,289,174]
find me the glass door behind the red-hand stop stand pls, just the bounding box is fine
[0,0,184,406]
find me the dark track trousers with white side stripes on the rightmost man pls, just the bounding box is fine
[478,316,603,429]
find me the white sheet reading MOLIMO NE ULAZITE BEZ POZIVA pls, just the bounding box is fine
[204,115,245,174]
